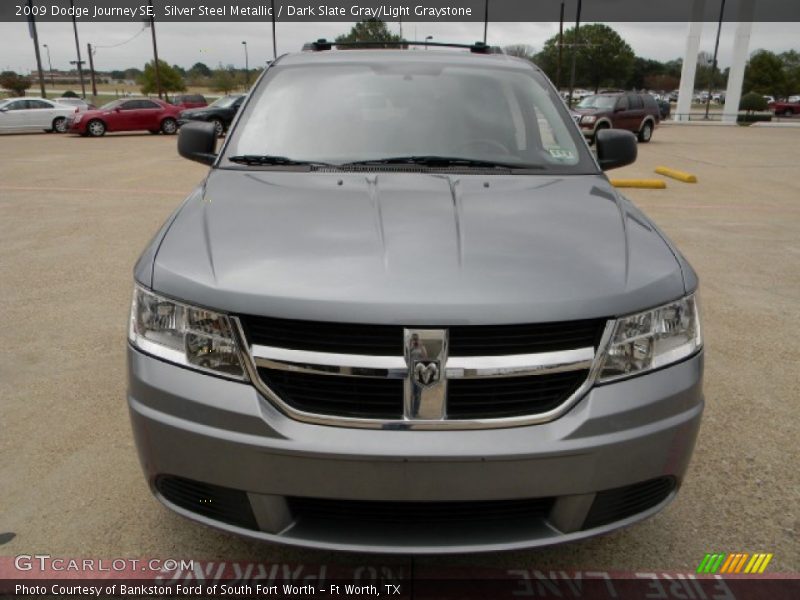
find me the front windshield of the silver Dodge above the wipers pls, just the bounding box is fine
[226,61,592,172]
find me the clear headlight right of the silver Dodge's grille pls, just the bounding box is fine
[598,294,703,382]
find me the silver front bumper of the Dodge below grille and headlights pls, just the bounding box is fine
[128,347,703,553]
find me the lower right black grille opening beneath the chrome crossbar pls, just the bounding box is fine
[447,370,589,419]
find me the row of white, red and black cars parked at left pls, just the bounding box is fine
[0,94,245,137]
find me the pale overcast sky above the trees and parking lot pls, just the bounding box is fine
[0,19,800,73]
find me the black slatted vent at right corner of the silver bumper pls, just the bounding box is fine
[583,477,675,529]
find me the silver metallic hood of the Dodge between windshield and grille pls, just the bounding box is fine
[152,169,684,325]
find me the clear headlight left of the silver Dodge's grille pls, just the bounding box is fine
[128,285,246,379]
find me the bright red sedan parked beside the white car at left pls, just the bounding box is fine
[69,98,181,137]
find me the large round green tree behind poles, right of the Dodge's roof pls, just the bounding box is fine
[536,23,635,92]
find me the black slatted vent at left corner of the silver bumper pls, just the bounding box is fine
[156,475,258,529]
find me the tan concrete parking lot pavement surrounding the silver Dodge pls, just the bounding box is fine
[0,126,800,572]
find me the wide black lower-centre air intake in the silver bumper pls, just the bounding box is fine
[287,498,554,527]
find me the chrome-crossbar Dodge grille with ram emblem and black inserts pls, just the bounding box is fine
[234,316,611,429]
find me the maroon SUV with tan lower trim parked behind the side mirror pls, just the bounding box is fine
[575,92,661,143]
